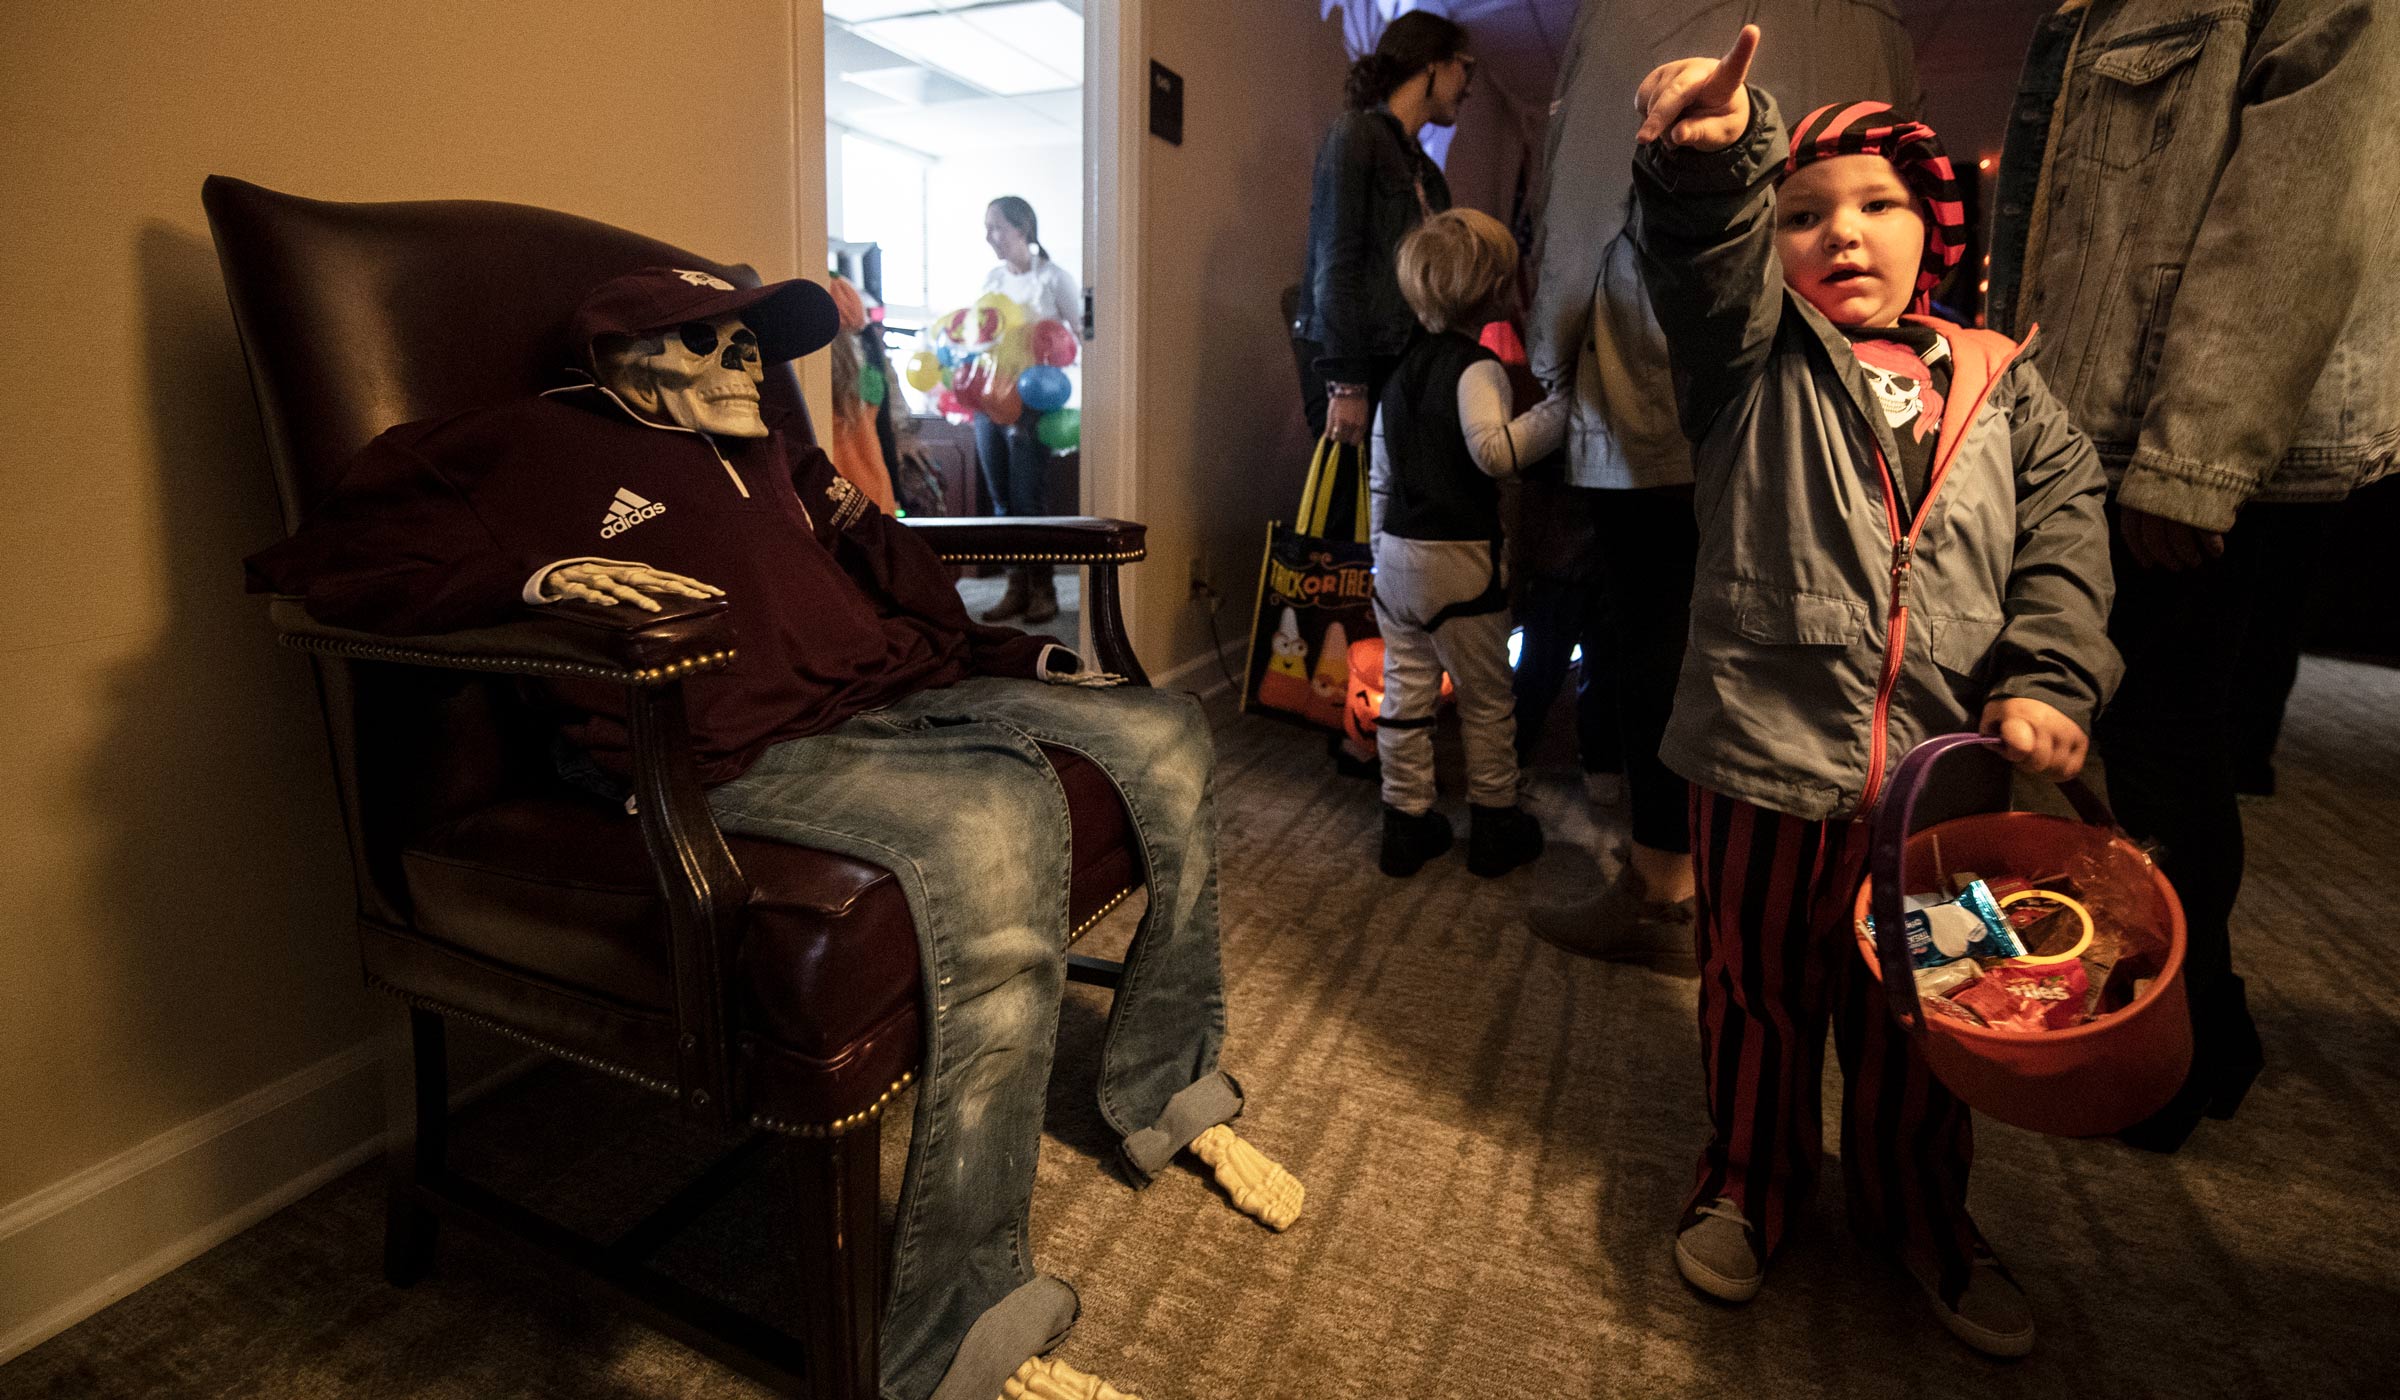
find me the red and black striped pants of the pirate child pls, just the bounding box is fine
[1685,785,1978,1287]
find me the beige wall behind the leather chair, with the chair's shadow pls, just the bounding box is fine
[0,0,823,1205]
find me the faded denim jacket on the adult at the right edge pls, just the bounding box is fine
[1992,0,2400,531]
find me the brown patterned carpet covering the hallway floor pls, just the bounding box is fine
[0,660,2400,1400]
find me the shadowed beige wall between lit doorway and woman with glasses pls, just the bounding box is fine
[1135,0,1346,672]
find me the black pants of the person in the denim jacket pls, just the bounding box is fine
[2093,504,2340,1112]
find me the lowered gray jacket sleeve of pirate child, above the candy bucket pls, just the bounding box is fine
[1990,360,2124,735]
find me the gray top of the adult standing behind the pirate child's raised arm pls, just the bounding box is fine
[1526,0,1918,490]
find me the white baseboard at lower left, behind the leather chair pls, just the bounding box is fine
[0,1040,542,1364]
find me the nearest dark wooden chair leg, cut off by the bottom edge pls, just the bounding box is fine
[790,1121,883,1400]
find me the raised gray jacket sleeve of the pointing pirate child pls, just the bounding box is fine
[1632,86,1788,442]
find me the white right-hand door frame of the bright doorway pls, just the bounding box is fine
[1082,0,1150,648]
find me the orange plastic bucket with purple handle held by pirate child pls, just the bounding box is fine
[1858,735,2191,1138]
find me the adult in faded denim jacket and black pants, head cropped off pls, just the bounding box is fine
[1990,0,2400,1150]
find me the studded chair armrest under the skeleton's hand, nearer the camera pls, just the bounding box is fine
[269,598,734,687]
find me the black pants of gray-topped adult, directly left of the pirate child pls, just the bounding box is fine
[1586,485,1699,852]
